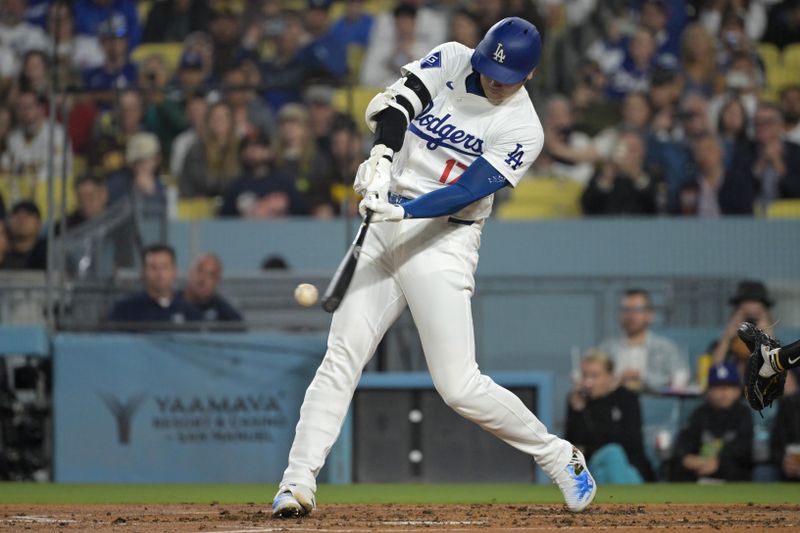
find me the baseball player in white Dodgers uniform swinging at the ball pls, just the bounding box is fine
[272,17,597,517]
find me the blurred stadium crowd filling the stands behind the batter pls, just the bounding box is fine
[0,0,800,231]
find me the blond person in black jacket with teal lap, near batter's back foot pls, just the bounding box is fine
[566,351,655,484]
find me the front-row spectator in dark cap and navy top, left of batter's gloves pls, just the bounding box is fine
[220,132,308,219]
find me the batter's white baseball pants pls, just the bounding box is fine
[281,218,572,490]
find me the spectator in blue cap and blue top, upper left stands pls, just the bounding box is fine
[82,14,138,109]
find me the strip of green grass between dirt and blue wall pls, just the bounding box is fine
[0,483,800,504]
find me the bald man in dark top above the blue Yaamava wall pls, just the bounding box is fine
[183,254,242,322]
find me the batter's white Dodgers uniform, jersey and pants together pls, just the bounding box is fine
[281,39,572,491]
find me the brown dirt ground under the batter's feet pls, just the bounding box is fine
[0,503,800,533]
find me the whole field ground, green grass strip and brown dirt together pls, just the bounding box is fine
[0,484,800,533]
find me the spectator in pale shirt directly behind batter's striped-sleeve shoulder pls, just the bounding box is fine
[361,3,430,87]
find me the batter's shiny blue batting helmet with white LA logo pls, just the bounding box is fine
[471,17,542,85]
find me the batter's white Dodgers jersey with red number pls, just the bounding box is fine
[391,42,544,220]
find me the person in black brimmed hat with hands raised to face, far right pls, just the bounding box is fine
[712,279,774,364]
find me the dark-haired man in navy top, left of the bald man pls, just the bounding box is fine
[108,244,203,324]
